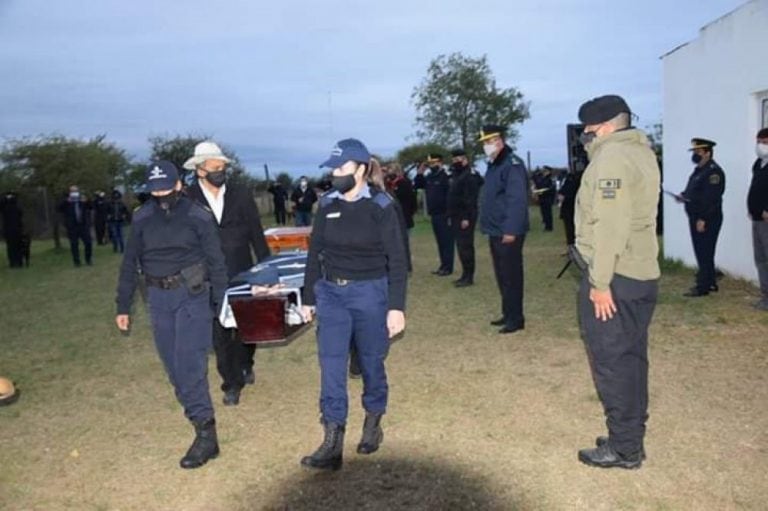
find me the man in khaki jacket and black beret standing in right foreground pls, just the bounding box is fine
[576,95,661,468]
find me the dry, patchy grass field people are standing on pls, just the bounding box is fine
[0,214,768,511]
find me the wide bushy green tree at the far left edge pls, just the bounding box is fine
[0,135,130,248]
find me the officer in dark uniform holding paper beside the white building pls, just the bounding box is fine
[678,138,725,297]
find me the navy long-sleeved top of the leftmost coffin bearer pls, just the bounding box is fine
[116,197,227,314]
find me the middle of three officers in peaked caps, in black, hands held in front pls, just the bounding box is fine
[447,149,480,287]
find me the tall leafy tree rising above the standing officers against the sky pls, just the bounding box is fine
[411,53,530,154]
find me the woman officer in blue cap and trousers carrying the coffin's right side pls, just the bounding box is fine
[301,139,407,470]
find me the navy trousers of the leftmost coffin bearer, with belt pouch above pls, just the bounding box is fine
[148,286,213,422]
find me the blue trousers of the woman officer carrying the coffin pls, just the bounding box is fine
[315,278,389,425]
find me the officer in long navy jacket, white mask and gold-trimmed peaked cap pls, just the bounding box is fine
[479,124,529,334]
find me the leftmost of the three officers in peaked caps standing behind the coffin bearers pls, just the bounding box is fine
[413,154,454,277]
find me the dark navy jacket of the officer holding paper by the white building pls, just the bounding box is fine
[682,160,725,221]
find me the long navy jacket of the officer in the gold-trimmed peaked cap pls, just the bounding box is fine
[480,146,529,236]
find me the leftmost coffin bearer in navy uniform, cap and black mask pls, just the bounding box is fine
[116,161,227,468]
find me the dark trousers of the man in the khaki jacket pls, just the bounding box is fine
[578,274,658,455]
